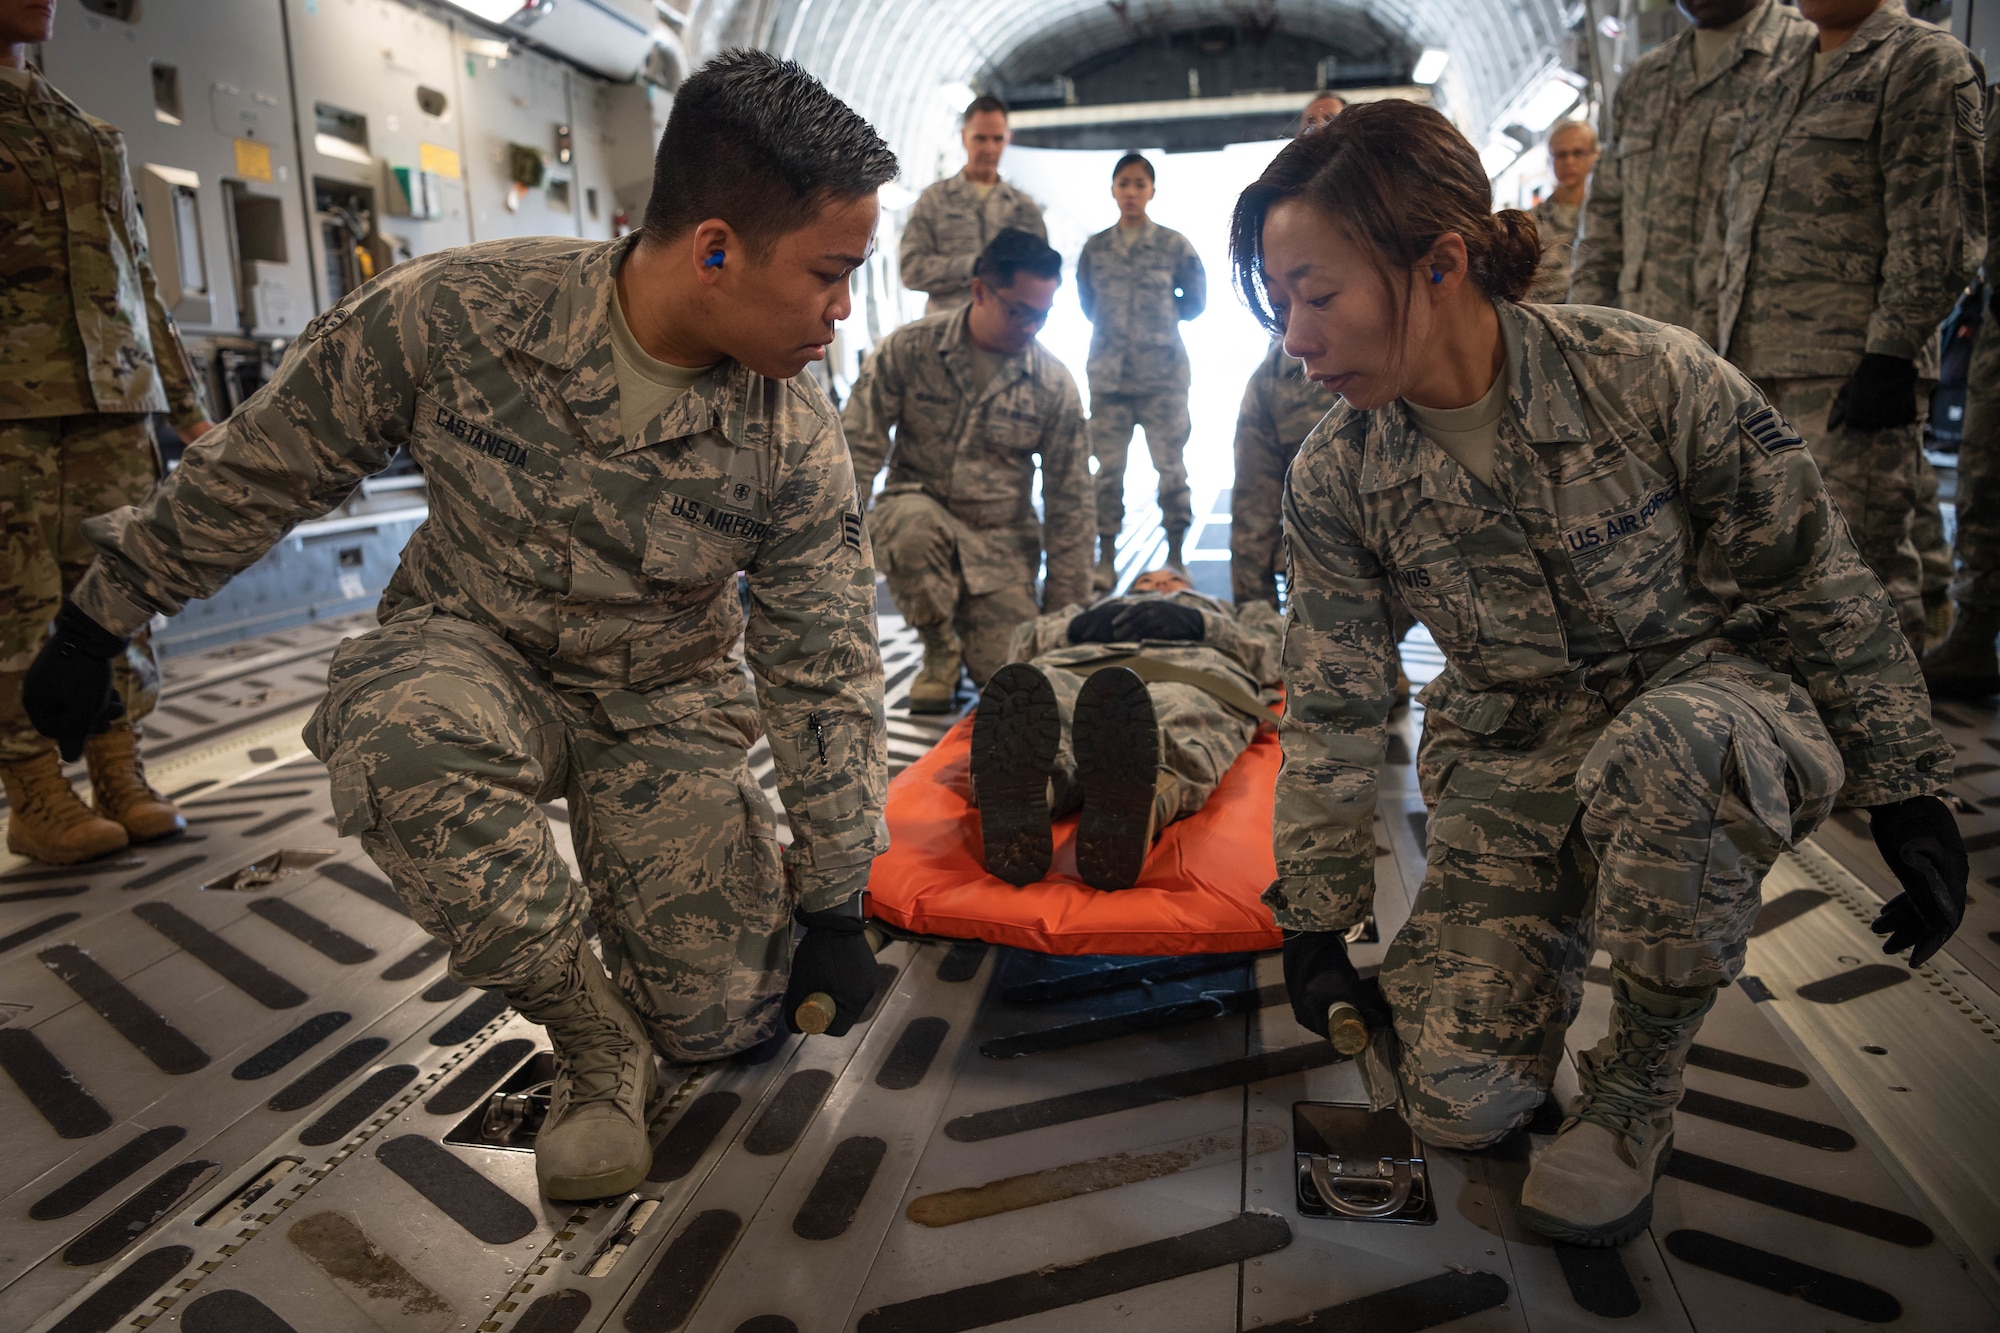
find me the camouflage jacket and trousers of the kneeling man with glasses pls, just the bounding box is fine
[842,312,1090,685]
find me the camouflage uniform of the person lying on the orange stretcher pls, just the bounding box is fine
[1008,592,1284,831]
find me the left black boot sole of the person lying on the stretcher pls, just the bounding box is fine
[972,662,1062,885]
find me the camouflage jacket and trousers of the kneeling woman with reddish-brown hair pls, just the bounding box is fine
[1266,304,1952,1147]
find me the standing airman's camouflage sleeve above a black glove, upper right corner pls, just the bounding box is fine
[1866,32,1986,360]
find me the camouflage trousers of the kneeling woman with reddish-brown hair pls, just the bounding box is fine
[1362,654,1844,1149]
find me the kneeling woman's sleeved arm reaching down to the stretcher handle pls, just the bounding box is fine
[1264,426,1396,931]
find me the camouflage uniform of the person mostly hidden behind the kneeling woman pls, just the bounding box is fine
[1230,338,1334,606]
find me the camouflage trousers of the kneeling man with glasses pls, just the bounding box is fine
[868,492,1042,685]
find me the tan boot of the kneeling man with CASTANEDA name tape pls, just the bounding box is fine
[508,945,658,1199]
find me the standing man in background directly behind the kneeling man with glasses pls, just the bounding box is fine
[898,96,1048,316]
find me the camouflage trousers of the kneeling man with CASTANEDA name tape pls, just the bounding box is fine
[306,608,792,1061]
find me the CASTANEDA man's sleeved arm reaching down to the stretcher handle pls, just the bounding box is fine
[744,384,888,913]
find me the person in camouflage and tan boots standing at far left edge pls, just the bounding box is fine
[0,0,208,865]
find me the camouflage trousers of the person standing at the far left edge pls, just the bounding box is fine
[0,412,160,765]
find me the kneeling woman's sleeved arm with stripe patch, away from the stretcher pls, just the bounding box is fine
[1660,328,1952,807]
